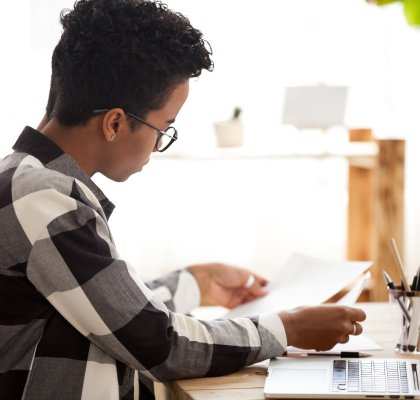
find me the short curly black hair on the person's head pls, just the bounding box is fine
[47,0,213,128]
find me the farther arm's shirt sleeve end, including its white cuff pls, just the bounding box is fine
[145,269,201,314]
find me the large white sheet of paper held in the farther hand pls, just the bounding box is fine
[225,254,372,318]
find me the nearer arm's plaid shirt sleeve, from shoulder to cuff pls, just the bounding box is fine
[26,184,287,382]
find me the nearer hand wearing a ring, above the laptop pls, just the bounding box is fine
[279,305,366,351]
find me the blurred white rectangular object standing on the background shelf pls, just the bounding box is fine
[282,86,347,129]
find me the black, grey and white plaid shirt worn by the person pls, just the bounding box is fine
[0,127,287,400]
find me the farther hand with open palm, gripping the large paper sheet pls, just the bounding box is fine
[186,263,268,308]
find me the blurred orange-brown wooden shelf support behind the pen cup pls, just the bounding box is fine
[347,129,405,301]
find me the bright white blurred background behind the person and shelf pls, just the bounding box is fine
[0,0,420,290]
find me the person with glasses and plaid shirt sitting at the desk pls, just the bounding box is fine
[0,0,365,400]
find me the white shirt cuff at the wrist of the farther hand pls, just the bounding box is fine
[173,269,201,314]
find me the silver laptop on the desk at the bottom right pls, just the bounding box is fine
[264,357,420,399]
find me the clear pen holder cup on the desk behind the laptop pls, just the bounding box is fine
[388,285,420,354]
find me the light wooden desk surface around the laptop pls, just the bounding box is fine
[171,303,420,400]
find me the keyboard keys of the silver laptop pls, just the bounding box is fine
[332,360,408,393]
